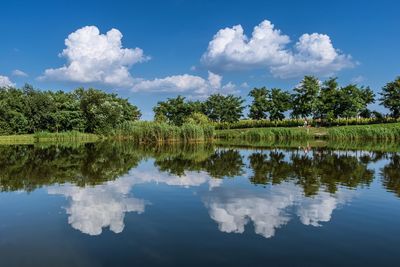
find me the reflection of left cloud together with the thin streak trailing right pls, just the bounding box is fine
[48,169,222,235]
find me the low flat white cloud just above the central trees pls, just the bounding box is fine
[133,72,237,97]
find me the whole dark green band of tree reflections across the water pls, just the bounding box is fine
[0,142,400,199]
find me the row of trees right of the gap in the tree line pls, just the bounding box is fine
[153,76,400,125]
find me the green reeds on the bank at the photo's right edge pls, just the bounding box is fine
[328,123,400,140]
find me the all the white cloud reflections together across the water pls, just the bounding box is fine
[49,168,353,238]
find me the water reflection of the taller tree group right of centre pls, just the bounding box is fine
[249,150,374,196]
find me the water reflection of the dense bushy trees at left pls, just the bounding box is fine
[0,143,140,191]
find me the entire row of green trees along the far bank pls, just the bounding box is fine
[0,76,400,135]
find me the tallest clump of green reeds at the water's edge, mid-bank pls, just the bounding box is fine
[112,121,214,143]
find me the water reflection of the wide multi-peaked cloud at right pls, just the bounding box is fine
[204,182,352,238]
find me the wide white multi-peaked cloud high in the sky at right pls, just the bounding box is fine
[201,20,354,78]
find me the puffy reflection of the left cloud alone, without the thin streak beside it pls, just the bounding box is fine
[48,177,146,235]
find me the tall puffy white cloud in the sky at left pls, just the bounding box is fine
[40,26,149,87]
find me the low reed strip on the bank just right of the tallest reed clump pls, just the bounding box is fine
[215,128,312,142]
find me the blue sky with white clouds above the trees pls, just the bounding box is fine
[0,0,400,119]
